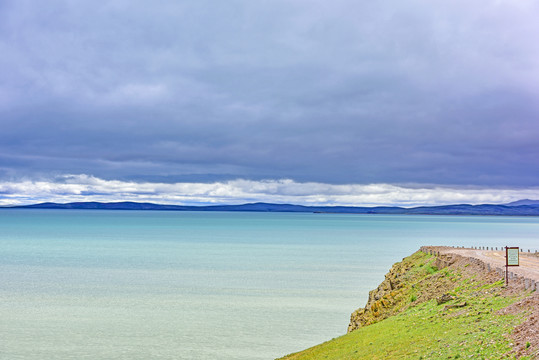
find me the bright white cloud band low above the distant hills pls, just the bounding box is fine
[0,175,539,207]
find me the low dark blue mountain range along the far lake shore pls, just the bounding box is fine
[6,199,539,216]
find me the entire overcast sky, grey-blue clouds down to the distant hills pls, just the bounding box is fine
[0,0,539,206]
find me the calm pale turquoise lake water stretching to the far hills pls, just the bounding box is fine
[0,209,539,360]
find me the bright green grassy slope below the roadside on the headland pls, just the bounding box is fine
[283,252,531,360]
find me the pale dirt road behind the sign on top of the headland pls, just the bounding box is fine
[439,247,539,281]
